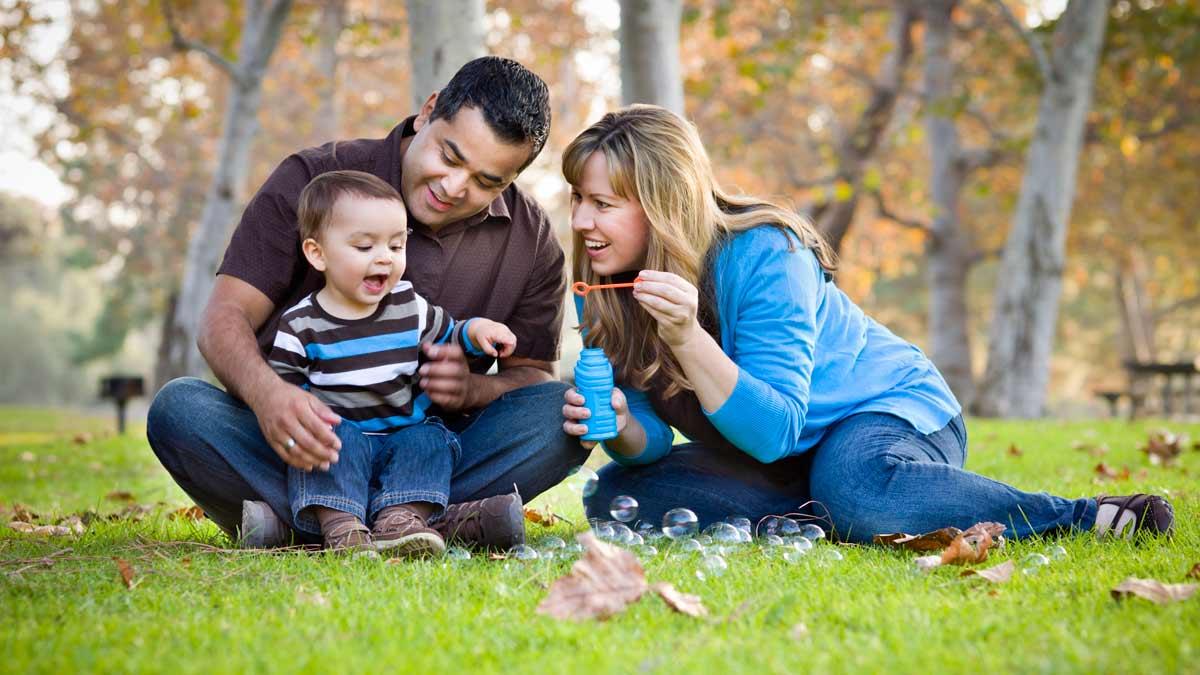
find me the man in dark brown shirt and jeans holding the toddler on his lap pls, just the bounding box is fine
[146,56,587,546]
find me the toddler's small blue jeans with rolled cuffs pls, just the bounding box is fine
[288,417,462,534]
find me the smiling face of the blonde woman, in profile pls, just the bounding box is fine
[571,153,650,276]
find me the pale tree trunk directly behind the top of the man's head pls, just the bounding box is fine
[408,0,487,112]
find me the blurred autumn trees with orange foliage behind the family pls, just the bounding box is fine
[0,0,1200,416]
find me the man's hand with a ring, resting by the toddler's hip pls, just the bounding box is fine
[251,380,342,471]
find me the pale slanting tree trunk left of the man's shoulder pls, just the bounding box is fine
[168,0,292,376]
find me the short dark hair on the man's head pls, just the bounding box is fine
[430,56,550,171]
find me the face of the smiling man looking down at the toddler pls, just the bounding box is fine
[400,97,530,229]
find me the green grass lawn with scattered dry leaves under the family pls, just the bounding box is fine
[0,401,1200,674]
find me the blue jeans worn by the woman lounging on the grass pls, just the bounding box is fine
[584,413,1096,543]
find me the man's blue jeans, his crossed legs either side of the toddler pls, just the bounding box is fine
[146,377,588,543]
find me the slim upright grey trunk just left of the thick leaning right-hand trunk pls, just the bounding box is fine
[924,0,974,406]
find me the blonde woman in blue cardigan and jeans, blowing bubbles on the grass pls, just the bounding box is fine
[563,106,1174,542]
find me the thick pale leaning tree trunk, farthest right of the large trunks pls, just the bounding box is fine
[978,0,1109,418]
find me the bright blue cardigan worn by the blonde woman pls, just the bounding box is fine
[575,226,961,465]
